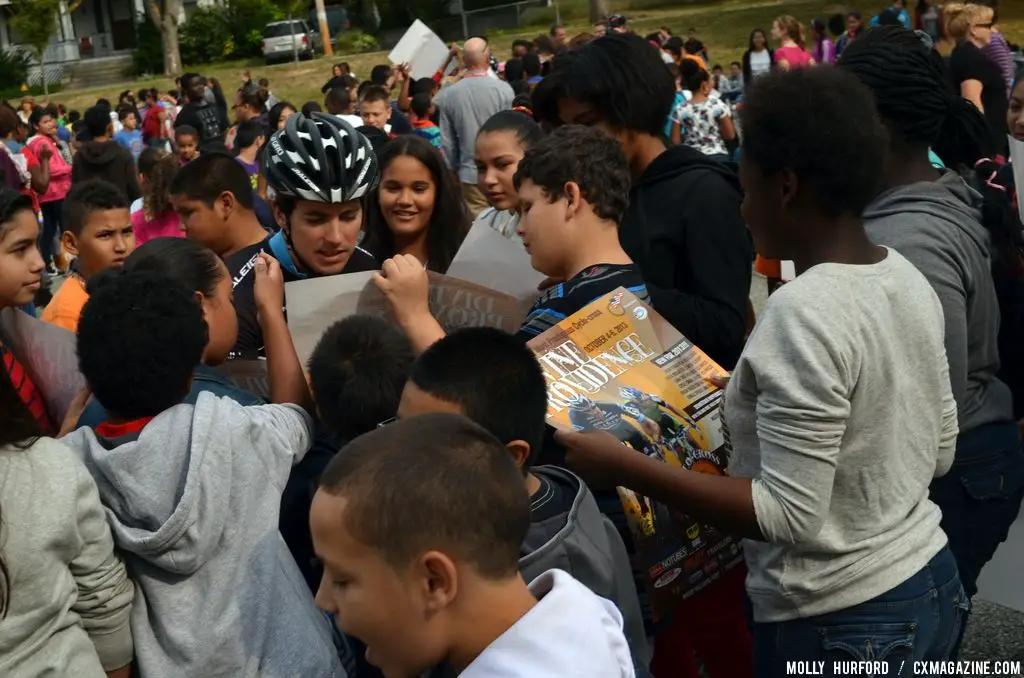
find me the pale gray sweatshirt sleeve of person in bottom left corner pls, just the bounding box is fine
[69,450,135,671]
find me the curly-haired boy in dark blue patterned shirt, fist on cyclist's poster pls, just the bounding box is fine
[375,125,647,352]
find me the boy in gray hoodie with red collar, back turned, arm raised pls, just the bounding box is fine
[65,262,345,678]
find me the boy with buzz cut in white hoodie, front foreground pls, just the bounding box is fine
[309,414,635,678]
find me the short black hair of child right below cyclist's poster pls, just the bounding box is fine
[308,315,414,440]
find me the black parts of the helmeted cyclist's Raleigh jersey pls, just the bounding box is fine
[224,238,380,358]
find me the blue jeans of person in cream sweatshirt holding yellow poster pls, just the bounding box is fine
[754,547,970,678]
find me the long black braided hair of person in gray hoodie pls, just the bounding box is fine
[839,26,991,167]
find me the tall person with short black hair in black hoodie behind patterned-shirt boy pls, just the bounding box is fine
[534,34,754,369]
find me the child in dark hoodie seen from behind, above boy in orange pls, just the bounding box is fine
[71,107,142,203]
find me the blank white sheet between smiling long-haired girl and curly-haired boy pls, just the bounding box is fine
[446,221,545,302]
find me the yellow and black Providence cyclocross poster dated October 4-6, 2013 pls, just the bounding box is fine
[529,288,742,617]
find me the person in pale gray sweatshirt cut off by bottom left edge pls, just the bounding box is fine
[0,360,134,678]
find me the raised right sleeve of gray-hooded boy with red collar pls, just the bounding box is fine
[242,405,313,490]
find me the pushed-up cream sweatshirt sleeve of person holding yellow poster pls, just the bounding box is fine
[748,305,856,544]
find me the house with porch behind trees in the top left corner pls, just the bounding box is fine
[0,0,218,82]
